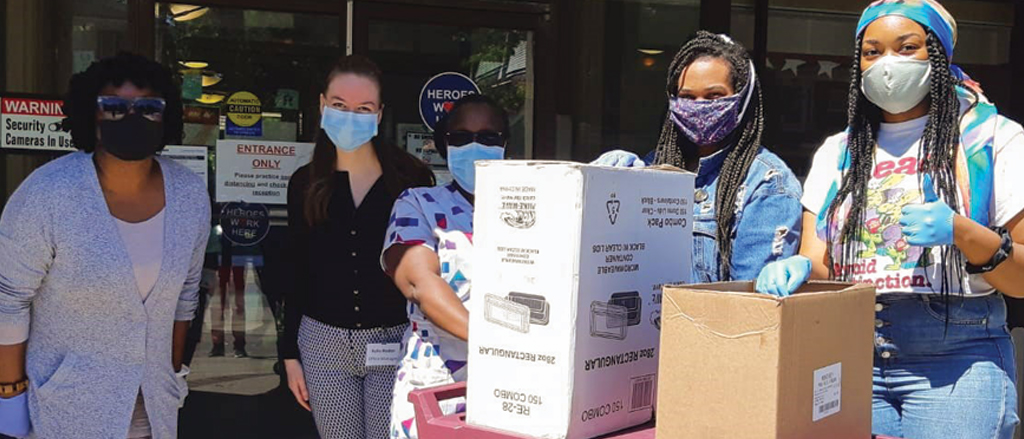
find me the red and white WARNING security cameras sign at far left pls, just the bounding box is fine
[0,95,75,152]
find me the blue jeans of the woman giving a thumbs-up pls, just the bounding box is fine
[871,295,1020,439]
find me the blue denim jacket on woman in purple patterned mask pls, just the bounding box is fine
[692,147,803,282]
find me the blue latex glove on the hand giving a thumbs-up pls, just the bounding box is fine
[899,174,954,247]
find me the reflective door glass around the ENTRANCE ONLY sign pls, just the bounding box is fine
[156,3,341,437]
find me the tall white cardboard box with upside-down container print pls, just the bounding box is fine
[467,162,694,439]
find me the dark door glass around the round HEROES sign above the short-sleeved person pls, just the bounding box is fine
[369,20,534,182]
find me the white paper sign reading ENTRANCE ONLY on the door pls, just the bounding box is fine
[216,140,313,205]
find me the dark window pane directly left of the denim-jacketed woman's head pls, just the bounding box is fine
[574,0,700,160]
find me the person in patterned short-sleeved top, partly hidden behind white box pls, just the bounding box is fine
[381,95,509,438]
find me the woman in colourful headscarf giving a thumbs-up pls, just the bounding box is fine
[758,0,1024,439]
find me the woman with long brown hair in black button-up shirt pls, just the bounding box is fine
[282,55,433,439]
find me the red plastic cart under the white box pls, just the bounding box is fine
[409,383,654,439]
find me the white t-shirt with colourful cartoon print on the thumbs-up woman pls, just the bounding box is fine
[802,116,1024,296]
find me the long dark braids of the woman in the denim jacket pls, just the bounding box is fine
[654,31,764,280]
